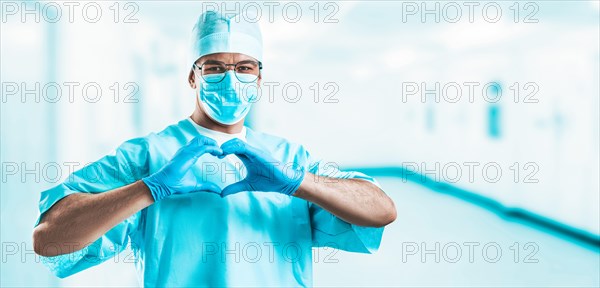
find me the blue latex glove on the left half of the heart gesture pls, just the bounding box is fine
[142,136,223,201]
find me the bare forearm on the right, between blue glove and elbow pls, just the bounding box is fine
[294,173,396,227]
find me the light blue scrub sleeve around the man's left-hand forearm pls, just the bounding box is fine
[35,138,148,278]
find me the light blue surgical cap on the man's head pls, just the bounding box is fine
[189,11,262,63]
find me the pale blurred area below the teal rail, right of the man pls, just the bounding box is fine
[315,176,600,287]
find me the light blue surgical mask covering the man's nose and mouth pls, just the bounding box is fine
[196,71,258,125]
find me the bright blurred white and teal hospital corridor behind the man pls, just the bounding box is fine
[0,0,600,287]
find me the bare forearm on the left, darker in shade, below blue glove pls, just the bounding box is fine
[33,181,154,256]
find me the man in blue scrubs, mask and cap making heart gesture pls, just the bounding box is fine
[33,12,396,286]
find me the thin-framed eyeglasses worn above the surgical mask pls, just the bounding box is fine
[194,60,262,83]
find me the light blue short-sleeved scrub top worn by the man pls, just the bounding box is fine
[36,119,383,286]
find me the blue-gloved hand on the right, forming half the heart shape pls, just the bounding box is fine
[219,138,305,197]
